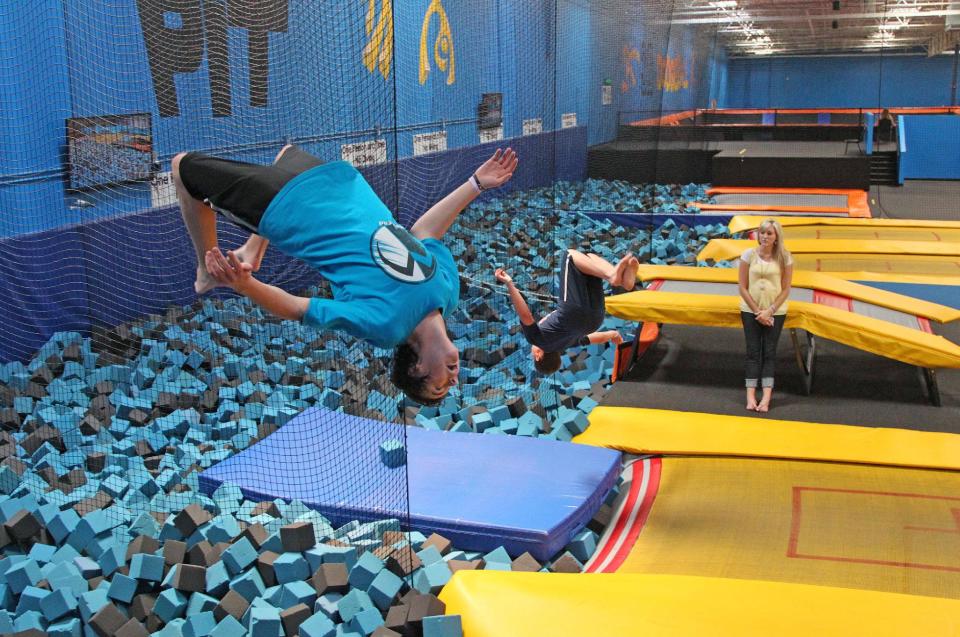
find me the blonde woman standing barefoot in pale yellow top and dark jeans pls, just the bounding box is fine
[739,219,793,413]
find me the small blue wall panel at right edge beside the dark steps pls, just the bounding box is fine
[900,115,960,179]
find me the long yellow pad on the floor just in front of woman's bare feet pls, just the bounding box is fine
[574,406,960,470]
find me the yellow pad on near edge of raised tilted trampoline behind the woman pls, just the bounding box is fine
[606,290,960,368]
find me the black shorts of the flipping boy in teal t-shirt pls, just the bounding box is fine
[180,146,323,232]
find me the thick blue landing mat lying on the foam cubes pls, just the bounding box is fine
[200,409,620,561]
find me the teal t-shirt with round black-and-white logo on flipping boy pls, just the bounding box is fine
[259,161,460,348]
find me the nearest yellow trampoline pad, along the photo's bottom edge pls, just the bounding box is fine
[440,571,960,637]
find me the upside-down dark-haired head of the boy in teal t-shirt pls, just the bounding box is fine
[390,337,460,405]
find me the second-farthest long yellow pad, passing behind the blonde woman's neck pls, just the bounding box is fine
[697,238,960,261]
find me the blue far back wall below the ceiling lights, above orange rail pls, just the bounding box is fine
[722,54,953,108]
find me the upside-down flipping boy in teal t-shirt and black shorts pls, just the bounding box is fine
[172,145,517,404]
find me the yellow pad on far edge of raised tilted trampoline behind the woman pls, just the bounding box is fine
[637,265,960,323]
